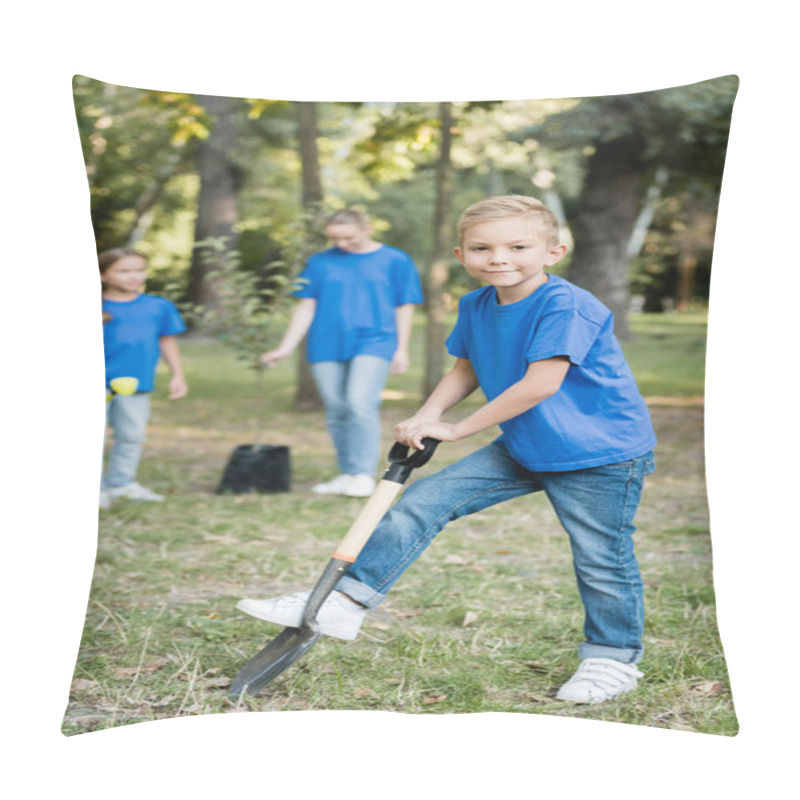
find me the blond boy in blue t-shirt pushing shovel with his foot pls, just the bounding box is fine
[238,196,656,703]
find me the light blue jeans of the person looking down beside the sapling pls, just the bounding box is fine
[311,356,391,475]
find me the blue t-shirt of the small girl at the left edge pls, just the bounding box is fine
[103,294,186,392]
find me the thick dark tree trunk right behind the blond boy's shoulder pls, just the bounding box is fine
[569,135,644,339]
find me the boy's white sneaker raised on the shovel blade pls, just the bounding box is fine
[236,592,367,640]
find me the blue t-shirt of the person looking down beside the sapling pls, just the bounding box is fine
[294,245,423,363]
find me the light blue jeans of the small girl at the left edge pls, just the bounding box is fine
[100,392,150,489]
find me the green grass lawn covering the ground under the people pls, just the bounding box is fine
[63,315,737,735]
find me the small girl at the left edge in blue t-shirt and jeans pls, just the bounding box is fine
[98,248,189,508]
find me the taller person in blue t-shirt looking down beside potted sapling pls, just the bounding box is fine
[261,208,422,497]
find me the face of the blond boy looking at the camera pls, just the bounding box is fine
[454,217,567,305]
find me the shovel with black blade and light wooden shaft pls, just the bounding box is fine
[230,438,439,697]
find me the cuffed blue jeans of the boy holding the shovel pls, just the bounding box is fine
[337,441,655,663]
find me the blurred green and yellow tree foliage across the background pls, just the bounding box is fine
[74,76,737,350]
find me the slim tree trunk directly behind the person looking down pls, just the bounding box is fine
[294,102,324,411]
